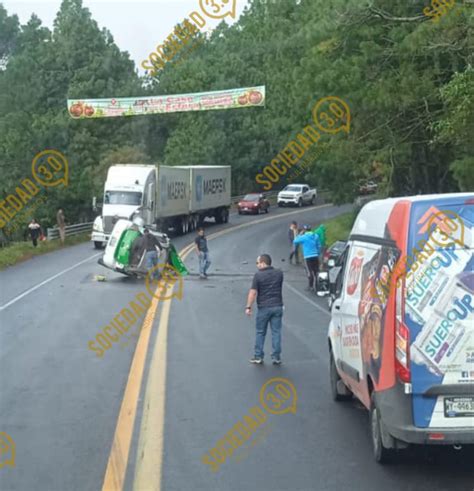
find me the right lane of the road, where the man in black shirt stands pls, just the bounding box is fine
[131,204,474,491]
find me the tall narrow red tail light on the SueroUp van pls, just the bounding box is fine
[395,278,411,383]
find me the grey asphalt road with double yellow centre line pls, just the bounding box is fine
[0,202,474,491]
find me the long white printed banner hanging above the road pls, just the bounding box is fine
[67,85,265,119]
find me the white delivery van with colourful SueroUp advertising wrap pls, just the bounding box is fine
[328,193,474,462]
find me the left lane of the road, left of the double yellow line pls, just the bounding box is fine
[0,203,348,490]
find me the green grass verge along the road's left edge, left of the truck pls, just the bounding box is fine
[0,232,91,271]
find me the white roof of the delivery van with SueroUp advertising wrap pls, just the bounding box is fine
[351,193,474,238]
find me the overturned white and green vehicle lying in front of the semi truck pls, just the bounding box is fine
[98,219,170,278]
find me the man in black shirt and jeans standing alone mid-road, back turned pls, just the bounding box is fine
[245,254,283,365]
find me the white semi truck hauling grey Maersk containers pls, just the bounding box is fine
[91,164,231,248]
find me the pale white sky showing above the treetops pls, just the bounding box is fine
[0,0,248,73]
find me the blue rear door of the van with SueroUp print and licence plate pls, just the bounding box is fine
[404,195,474,428]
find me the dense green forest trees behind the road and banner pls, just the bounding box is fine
[0,0,474,238]
